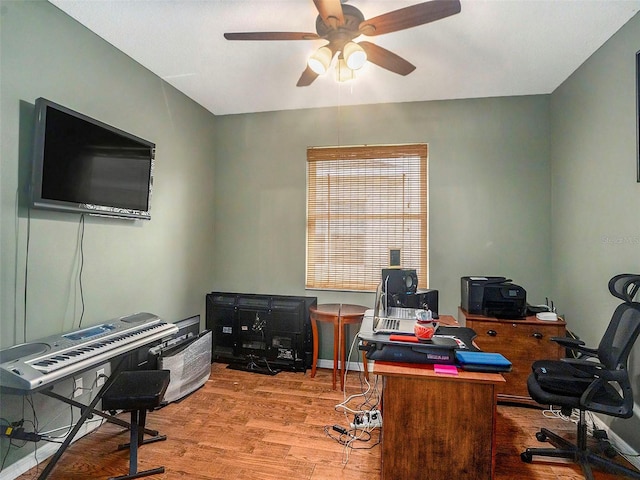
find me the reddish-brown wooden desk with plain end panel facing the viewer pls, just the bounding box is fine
[373,362,505,480]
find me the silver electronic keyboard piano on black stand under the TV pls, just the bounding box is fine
[0,313,178,391]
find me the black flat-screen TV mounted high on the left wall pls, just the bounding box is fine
[31,98,155,220]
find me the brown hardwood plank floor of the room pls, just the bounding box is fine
[12,363,636,480]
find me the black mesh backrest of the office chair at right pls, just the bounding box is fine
[598,302,640,370]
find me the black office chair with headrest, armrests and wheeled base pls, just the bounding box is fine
[520,274,640,480]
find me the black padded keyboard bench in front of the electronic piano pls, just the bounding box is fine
[102,370,170,480]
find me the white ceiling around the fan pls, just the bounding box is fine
[49,0,640,115]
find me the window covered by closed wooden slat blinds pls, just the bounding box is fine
[306,144,428,291]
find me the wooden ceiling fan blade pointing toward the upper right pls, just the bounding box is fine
[359,0,461,36]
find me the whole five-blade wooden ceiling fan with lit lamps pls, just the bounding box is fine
[224,0,461,87]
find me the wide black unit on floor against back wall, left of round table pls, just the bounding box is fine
[206,292,317,371]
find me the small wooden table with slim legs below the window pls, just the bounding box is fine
[309,303,369,390]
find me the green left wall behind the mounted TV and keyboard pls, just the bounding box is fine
[0,0,215,472]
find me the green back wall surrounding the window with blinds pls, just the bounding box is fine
[213,96,551,358]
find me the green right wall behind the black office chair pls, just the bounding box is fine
[551,9,640,451]
